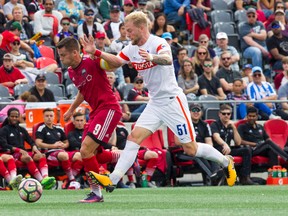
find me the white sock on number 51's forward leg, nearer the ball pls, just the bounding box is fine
[109,140,140,185]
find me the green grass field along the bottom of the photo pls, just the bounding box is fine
[0,186,288,216]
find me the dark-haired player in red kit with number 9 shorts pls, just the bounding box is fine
[57,36,122,203]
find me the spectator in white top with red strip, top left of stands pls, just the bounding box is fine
[34,0,63,45]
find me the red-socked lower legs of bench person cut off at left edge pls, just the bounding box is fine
[0,153,23,190]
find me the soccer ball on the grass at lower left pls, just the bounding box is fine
[18,178,43,202]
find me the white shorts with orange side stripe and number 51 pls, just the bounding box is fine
[136,93,196,143]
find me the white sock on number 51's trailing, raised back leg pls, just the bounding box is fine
[195,142,229,167]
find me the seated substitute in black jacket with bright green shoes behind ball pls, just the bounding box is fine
[0,108,56,189]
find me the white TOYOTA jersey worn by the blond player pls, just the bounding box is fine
[118,35,182,104]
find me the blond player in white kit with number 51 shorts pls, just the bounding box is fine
[82,12,237,192]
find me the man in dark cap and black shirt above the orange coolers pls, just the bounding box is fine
[29,74,55,102]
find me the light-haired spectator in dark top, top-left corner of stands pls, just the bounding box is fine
[6,6,34,40]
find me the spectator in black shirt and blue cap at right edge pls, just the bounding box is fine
[267,21,288,70]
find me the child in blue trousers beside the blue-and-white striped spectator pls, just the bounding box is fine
[226,79,253,119]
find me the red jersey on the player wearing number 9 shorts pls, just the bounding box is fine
[68,58,121,116]
